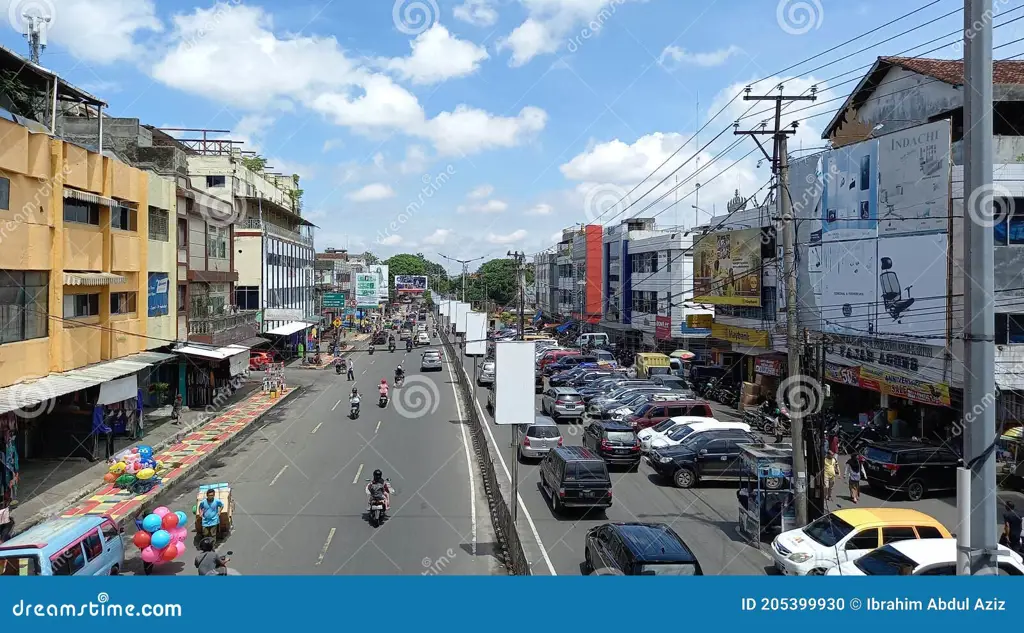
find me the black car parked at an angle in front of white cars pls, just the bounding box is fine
[647,428,761,488]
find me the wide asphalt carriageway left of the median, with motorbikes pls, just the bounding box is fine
[126,323,505,575]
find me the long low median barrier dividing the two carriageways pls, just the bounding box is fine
[438,329,531,576]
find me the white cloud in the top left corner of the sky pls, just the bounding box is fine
[0,0,164,64]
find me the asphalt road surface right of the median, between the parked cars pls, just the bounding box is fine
[464,342,770,576]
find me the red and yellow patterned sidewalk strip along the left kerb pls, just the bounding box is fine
[60,391,285,522]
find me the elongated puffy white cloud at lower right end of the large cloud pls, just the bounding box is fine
[425,106,548,155]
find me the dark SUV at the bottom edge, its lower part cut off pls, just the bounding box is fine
[584,523,703,576]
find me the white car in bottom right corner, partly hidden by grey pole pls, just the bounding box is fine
[825,539,1024,576]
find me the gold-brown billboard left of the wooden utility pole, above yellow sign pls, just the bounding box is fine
[693,228,762,306]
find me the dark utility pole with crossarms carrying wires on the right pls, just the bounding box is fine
[733,85,817,526]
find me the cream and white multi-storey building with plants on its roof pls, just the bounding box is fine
[188,143,311,346]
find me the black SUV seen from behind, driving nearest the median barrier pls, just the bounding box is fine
[541,447,611,513]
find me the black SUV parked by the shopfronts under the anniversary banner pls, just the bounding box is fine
[862,440,961,501]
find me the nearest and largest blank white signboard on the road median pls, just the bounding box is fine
[495,341,537,424]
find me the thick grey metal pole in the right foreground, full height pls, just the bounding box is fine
[957,0,997,575]
